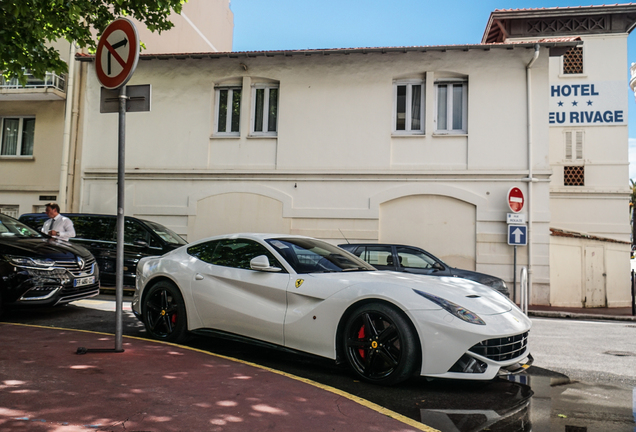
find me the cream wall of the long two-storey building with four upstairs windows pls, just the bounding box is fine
[81,44,550,302]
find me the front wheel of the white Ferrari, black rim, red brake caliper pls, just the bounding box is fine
[342,303,420,385]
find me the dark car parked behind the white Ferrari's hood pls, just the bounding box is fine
[338,243,510,297]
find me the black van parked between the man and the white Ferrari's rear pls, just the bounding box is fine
[20,213,187,290]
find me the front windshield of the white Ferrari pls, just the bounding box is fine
[267,238,375,274]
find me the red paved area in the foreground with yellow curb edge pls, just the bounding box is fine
[0,323,432,432]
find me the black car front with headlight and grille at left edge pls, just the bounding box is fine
[0,214,99,311]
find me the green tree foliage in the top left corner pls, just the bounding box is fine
[0,0,187,84]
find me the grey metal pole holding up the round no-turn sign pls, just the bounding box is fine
[115,85,126,352]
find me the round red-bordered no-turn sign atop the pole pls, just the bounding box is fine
[95,18,139,90]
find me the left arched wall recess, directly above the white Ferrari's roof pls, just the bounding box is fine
[188,192,291,241]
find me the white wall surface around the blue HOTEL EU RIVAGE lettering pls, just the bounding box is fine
[549,34,631,307]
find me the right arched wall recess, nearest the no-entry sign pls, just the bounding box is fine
[379,195,477,270]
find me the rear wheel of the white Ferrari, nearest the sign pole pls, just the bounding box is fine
[143,281,187,342]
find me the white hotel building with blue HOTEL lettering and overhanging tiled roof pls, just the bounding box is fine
[482,4,636,307]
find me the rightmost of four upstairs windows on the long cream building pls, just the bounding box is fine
[435,81,468,134]
